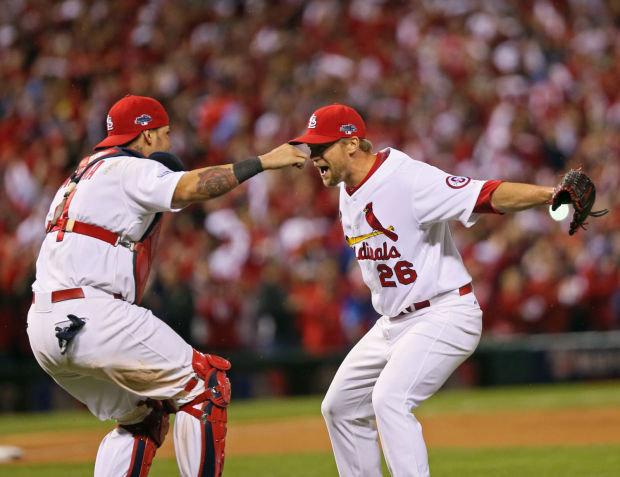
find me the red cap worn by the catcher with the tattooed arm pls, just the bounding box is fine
[93,94,170,149]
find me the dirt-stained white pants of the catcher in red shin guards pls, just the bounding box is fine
[28,287,212,477]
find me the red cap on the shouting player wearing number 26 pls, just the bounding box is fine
[289,103,366,144]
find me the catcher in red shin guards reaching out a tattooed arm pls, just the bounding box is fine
[28,95,306,477]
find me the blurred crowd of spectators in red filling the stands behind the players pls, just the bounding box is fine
[0,0,620,356]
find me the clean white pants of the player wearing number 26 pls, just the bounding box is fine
[321,290,482,477]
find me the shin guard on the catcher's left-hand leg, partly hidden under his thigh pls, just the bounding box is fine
[118,399,176,477]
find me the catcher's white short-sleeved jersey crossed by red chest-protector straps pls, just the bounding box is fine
[32,149,184,302]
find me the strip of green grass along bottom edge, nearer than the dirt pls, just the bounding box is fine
[0,445,620,477]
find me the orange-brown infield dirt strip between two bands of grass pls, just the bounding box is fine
[0,407,620,465]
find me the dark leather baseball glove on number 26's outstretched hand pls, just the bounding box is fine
[551,167,609,235]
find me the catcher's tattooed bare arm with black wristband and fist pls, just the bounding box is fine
[172,144,306,209]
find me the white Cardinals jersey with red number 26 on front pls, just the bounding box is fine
[340,148,485,316]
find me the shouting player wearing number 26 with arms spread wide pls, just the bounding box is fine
[290,104,553,477]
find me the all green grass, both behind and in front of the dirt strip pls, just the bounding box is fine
[0,381,620,477]
